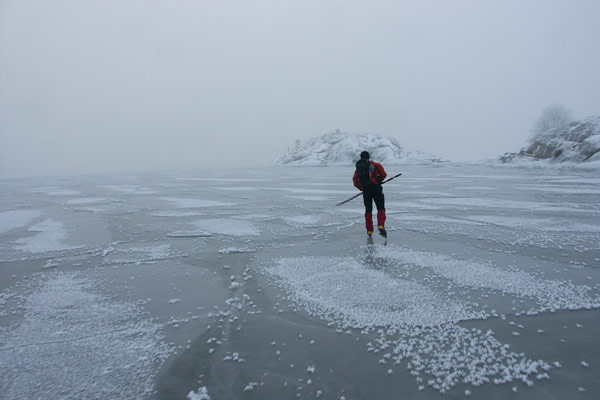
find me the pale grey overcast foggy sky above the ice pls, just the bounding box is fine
[0,0,600,176]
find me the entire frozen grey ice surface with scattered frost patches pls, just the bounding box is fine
[0,165,600,400]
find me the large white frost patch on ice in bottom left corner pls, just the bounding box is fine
[0,273,170,399]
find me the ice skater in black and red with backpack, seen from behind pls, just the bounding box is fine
[352,151,387,238]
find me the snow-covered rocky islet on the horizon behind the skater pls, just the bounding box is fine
[274,130,447,166]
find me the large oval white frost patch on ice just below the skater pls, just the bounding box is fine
[267,257,479,328]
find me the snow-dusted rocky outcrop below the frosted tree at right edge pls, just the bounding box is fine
[500,116,600,163]
